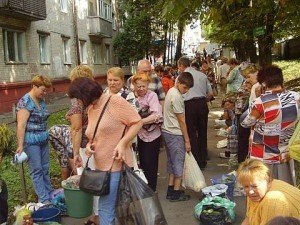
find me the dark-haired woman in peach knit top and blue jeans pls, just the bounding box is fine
[69,78,142,225]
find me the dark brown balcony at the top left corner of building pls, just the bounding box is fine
[0,0,46,21]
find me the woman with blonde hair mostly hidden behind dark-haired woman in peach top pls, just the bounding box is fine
[49,65,98,225]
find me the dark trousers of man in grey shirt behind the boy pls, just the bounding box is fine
[184,98,209,168]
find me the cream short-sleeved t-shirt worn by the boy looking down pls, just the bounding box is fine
[162,87,184,135]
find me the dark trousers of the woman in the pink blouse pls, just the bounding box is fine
[137,137,160,191]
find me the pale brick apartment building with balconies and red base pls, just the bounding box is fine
[0,0,117,113]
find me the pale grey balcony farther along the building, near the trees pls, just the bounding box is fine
[87,16,113,38]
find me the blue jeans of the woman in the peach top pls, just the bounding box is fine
[98,171,121,225]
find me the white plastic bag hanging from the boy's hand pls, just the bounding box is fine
[181,152,206,192]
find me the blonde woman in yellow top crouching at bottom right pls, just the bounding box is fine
[237,159,300,225]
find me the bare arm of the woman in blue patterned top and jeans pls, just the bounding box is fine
[17,109,30,154]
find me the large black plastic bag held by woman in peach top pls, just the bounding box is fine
[116,165,167,225]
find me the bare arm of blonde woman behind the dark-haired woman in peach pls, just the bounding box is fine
[70,114,83,167]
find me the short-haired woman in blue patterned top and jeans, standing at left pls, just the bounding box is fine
[17,75,53,204]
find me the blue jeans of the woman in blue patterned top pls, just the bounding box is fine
[25,143,53,202]
